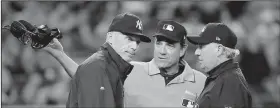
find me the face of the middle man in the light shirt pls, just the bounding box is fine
[154,36,183,68]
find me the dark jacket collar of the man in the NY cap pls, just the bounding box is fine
[101,43,133,75]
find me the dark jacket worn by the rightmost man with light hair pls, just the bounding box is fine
[198,59,252,108]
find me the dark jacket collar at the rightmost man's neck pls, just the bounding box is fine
[208,59,239,78]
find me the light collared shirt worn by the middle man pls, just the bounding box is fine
[124,60,206,107]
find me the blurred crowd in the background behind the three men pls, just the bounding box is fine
[1,1,280,107]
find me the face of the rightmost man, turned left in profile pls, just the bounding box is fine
[195,43,218,72]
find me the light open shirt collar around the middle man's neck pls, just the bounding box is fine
[148,59,195,84]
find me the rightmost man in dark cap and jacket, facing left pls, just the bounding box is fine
[188,23,252,108]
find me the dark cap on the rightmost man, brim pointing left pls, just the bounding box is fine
[187,23,237,49]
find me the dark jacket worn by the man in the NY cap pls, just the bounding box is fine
[66,43,133,108]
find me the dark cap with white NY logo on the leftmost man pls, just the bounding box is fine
[108,13,151,42]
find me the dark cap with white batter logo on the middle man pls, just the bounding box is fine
[154,20,187,42]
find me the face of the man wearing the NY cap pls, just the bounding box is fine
[111,32,140,62]
